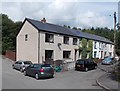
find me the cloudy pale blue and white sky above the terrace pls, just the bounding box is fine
[0,0,119,28]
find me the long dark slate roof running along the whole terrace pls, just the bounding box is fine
[26,18,113,44]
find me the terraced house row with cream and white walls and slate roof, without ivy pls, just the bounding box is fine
[16,18,113,63]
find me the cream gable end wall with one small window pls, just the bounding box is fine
[16,21,38,63]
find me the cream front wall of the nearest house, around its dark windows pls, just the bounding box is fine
[40,32,79,62]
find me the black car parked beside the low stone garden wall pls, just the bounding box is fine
[75,59,97,72]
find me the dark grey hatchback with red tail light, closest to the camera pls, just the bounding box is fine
[24,64,54,80]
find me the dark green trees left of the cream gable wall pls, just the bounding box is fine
[0,14,22,54]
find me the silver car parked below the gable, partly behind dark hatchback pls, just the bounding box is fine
[12,60,32,72]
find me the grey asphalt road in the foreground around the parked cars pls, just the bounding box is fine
[2,59,105,89]
